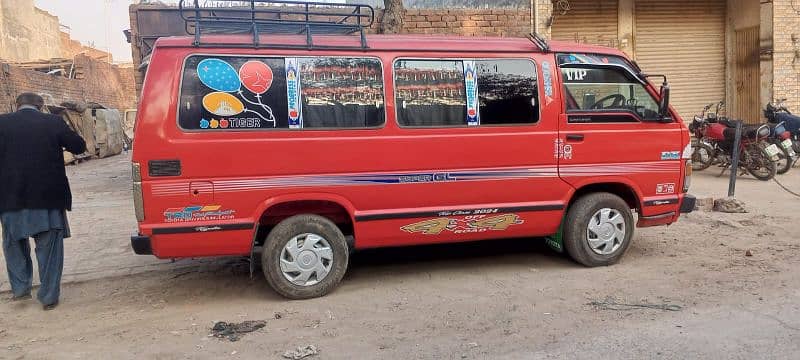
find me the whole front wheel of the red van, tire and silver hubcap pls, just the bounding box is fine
[564,193,633,267]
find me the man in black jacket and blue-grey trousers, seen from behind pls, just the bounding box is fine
[0,93,86,310]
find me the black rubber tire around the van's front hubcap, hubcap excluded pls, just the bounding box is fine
[564,193,634,267]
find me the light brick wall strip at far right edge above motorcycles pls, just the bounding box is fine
[773,0,800,112]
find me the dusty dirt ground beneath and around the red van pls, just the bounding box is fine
[0,156,800,359]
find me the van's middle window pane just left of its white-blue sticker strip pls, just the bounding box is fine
[394,60,467,127]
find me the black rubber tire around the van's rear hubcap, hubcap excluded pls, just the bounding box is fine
[261,215,350,300]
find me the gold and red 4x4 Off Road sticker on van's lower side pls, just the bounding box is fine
[400,214,524,235]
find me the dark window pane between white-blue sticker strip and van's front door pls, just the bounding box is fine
[476,60,539,125]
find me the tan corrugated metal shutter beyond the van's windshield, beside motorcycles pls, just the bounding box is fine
[634,0,725,121]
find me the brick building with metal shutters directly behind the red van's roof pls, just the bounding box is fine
[131,0,800,122]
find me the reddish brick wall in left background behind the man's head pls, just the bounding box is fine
[0,55,136,113]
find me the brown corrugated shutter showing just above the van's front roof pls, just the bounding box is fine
[551,0,618,47]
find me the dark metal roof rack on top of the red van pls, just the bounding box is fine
[178,0,375,50]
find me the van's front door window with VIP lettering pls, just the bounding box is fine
[561,67,659,120]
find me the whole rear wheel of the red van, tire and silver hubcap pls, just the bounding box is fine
[261,215,349,299]
